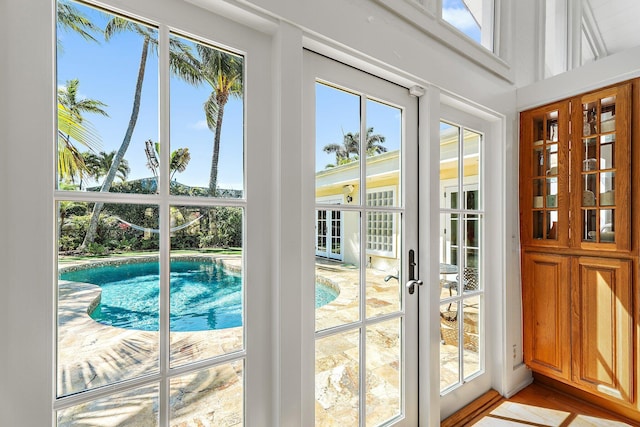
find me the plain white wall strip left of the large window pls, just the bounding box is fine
[0,0,54,426]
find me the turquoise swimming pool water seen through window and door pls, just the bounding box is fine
[60,261,338,332]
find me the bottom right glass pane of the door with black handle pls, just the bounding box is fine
[366,319,402,426]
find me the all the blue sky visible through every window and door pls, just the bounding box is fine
[57,0,470,189]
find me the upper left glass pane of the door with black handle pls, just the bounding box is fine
[316,83,360,204]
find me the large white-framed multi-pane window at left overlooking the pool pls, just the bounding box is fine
[54,0,249,426]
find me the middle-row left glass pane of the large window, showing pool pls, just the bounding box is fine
[57,201,160,396]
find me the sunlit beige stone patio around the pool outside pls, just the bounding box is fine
[57,256,477,427]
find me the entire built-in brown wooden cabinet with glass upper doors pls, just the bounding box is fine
[520,79,640,421]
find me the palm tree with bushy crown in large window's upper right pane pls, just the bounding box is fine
[196,44,243,196]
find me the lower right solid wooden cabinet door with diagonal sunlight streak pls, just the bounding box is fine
[571,257,634,403]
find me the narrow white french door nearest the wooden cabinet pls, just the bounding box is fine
[428,105,501,424]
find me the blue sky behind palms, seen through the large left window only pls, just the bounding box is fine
[57,3,243,189]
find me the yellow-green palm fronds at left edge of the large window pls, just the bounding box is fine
[58,79,109,181]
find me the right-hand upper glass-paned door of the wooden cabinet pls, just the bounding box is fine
[574,85,630,249]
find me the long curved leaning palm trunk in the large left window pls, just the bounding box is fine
[78,36,150,251]
